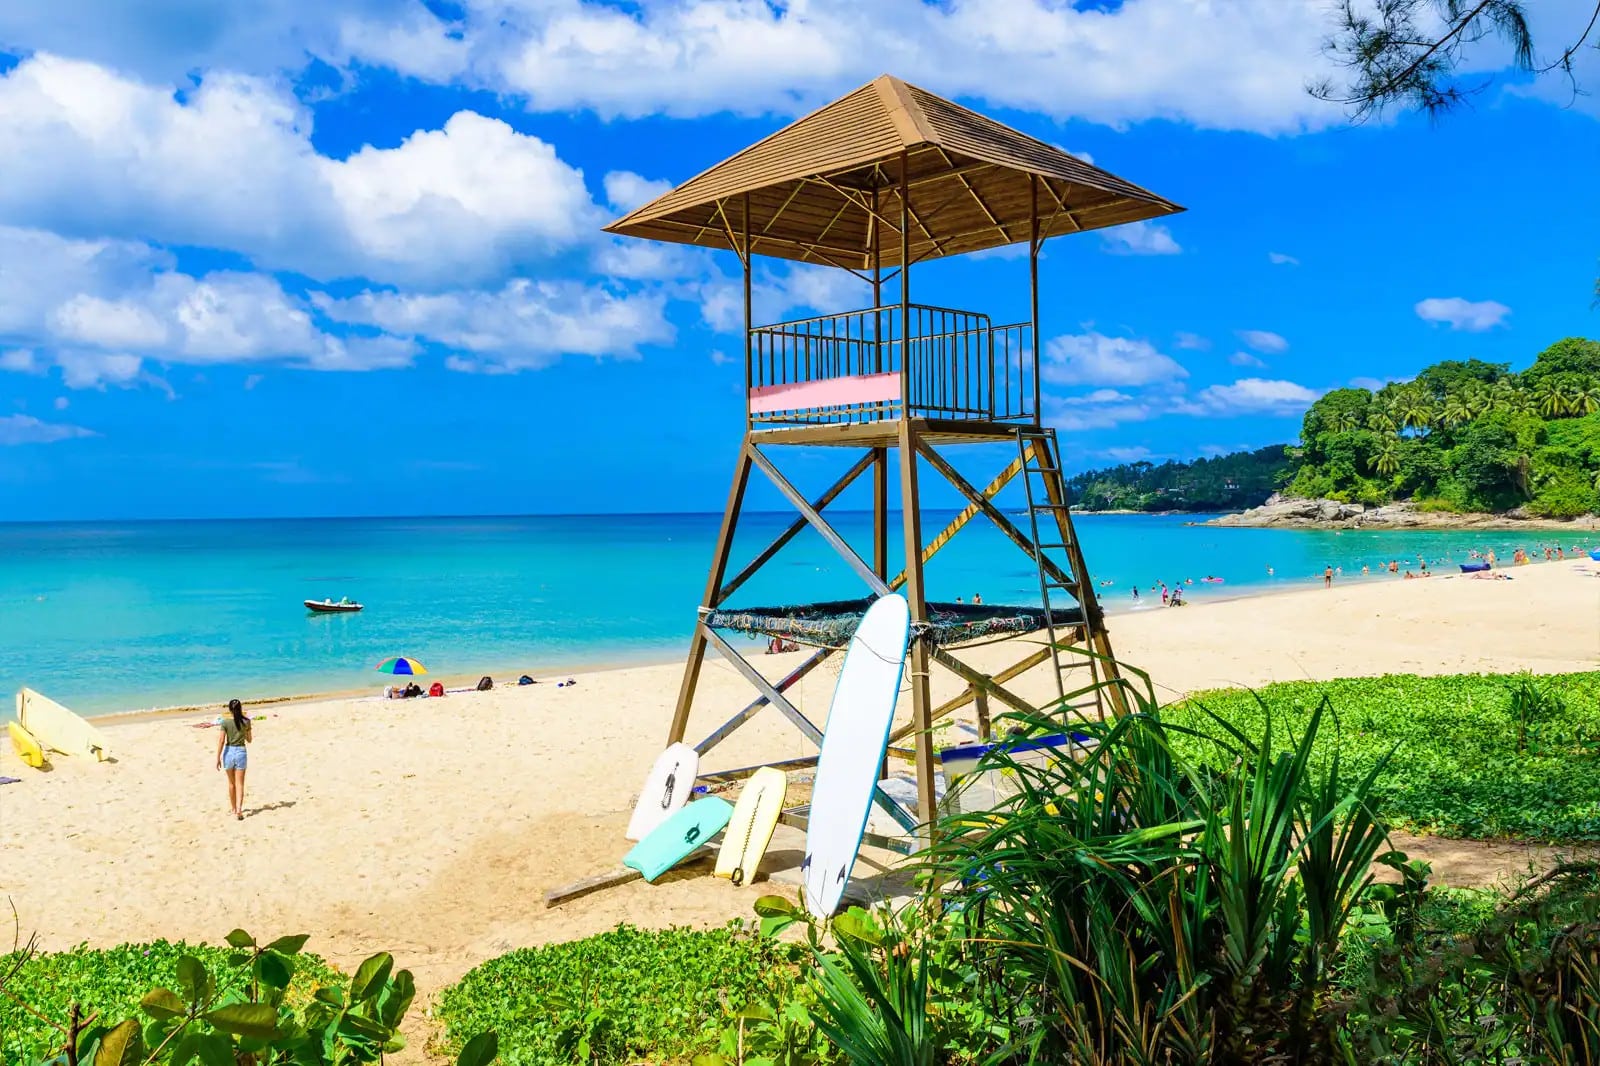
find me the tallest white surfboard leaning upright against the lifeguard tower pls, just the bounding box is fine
[800,592,910,917]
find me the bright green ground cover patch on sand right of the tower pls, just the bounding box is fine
[1162,672,1600,842]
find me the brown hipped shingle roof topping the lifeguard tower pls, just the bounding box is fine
[606,74,1182,271]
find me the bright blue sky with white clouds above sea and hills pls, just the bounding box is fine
[0,0,1600,520]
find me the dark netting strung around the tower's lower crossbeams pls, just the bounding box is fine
[704,599,1083,648]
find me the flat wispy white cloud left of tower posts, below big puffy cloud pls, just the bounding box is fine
[317,279,674,373]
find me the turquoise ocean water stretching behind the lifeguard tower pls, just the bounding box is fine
[0,512,1571,714]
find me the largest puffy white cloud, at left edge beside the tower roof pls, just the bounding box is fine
[0,54,605,285]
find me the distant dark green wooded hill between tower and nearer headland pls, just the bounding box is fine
[1067,445,1290,511]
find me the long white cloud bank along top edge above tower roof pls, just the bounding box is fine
[337,0,1341,133]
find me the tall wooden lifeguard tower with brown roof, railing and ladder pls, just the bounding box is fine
[606,75,1182,847]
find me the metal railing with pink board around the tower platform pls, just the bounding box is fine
[747,304,1038,426]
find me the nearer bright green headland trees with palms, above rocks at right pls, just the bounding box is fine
[1286,338,1600,519]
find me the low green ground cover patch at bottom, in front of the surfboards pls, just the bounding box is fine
[438,924,812,1066]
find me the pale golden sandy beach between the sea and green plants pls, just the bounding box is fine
[0,560,1600,1043]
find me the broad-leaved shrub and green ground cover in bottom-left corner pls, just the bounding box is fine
[0,928,496,1066]
